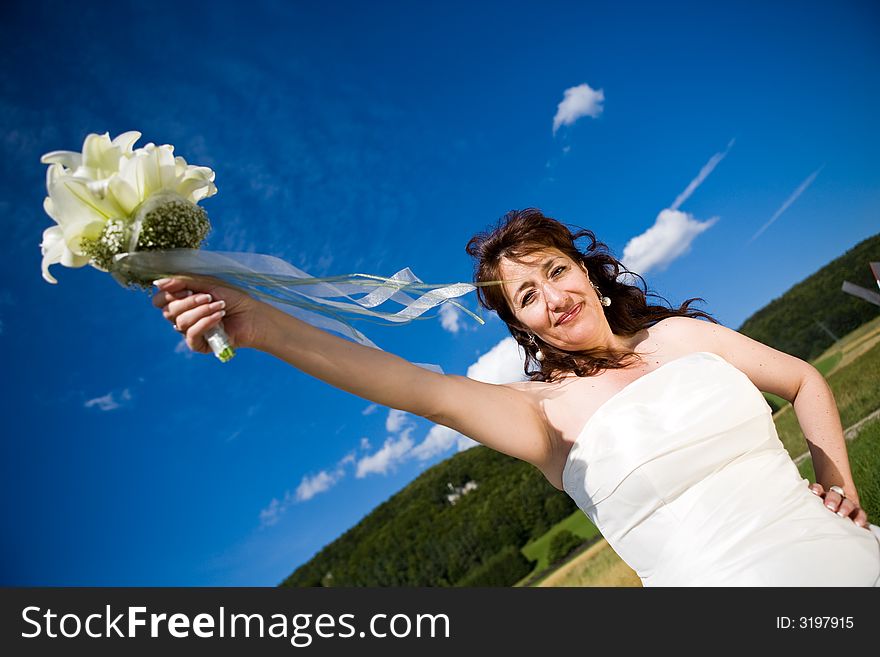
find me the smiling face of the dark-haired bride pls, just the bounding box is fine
[500,248,610,351]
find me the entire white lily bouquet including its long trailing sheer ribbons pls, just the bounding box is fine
[40,131,484,371]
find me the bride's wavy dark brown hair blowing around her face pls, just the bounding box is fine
[466,208,718,383]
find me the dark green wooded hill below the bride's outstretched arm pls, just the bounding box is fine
[281,445,577,586]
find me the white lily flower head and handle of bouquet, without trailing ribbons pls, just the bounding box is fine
[40,131,234,362]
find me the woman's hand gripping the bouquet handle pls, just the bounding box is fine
[153,276,259,354]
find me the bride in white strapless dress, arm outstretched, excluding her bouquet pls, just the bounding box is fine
[153,209,880,586]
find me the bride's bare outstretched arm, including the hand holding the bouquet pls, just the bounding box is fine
[153,277,551,467]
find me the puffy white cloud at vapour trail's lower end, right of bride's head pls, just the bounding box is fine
[621,209,718,276]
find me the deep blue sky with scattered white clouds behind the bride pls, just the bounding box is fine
[0,1,880,585]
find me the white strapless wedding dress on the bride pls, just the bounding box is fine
[562,351,880,586]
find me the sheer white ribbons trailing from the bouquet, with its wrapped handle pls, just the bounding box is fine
[111,249,485,373]
